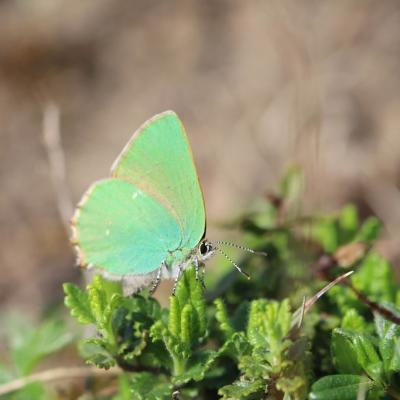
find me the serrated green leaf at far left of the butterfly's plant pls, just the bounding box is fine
[63,283,96,324]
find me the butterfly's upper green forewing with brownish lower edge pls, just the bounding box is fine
[112,111,205,248]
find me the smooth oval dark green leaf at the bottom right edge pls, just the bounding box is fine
[309,375,373,400]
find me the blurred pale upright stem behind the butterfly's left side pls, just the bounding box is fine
[43,103,74,236]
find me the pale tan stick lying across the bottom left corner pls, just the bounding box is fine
[0,367,122,396]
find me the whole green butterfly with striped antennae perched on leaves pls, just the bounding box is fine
[72,111,262,291]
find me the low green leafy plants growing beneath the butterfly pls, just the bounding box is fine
[0,168,400,400]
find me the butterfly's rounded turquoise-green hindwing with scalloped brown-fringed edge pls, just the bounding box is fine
[72,179,181,275]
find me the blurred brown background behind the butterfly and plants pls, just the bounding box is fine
[0,0,400,311]
